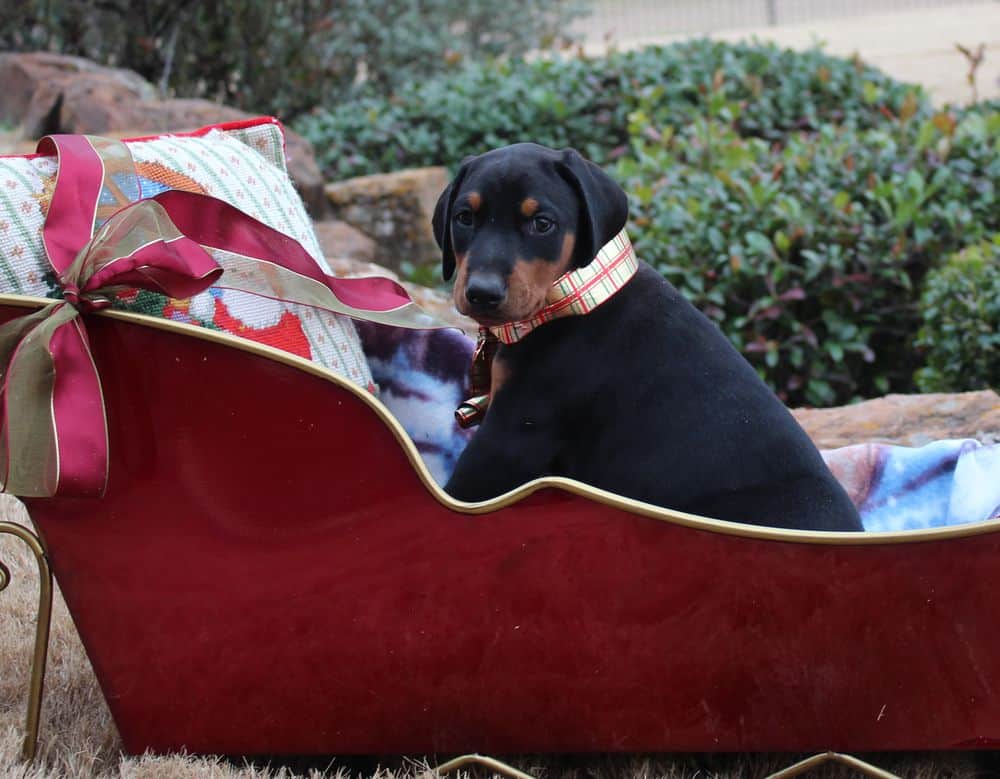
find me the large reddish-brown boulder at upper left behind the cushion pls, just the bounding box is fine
[0,53,327,218]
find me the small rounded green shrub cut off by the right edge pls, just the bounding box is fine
[916,235,1000,392]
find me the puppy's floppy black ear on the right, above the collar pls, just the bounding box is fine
[556,149,628,268]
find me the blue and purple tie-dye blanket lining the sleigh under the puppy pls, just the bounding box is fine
[357,322,1000,531]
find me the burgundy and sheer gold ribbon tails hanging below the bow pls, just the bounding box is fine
[0,303,108,497]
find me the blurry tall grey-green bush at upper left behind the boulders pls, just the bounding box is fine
[0,0,584,119]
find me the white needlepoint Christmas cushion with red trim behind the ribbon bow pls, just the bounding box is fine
[0,118,375,391]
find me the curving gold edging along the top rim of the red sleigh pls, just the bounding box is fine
[0,294,1000,546]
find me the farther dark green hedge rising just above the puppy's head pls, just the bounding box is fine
[296,40,930,178]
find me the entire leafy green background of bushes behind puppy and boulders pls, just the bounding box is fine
[0,6,1000,406]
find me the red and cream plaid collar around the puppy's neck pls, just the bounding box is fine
[490,229,639,344]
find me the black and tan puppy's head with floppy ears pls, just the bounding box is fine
[433,143,628,325]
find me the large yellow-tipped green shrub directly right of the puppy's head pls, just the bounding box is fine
[614,107,1000,405]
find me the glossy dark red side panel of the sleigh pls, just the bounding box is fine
[0,298,1000,754]
